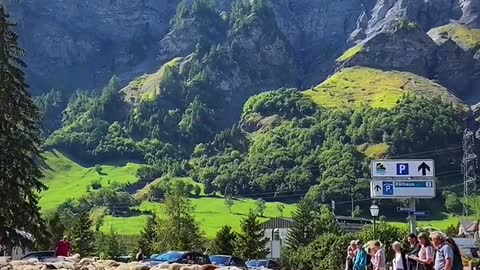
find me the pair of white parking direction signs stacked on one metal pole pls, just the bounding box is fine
[370,159,436,233]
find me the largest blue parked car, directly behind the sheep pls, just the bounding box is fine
[144,251,212,266]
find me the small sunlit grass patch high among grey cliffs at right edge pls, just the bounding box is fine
[428,23,480,51]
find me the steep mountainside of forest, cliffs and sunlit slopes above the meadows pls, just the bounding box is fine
[0,0,480,219]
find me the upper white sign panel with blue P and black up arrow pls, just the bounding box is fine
[371,159,435,178]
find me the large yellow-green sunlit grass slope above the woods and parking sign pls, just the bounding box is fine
[304,67,460,108]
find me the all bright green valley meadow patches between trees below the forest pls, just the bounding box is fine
[40,151,295,238]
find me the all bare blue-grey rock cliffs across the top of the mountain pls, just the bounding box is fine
[0,0,480,103]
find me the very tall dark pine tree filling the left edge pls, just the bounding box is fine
[0,4,46,248]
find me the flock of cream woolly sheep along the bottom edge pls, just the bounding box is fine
[0,255,241,270]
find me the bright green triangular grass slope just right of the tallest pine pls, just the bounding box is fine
[40,151,141,211]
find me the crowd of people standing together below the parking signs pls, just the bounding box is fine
[345,231,463,270]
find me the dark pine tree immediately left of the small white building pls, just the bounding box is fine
[235,210,268,259]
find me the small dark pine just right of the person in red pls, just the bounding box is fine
[70,210,94,256]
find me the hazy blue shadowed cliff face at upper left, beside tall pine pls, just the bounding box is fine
[0,0,179,93]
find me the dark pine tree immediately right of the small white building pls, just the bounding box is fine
[287,199,315,250]
